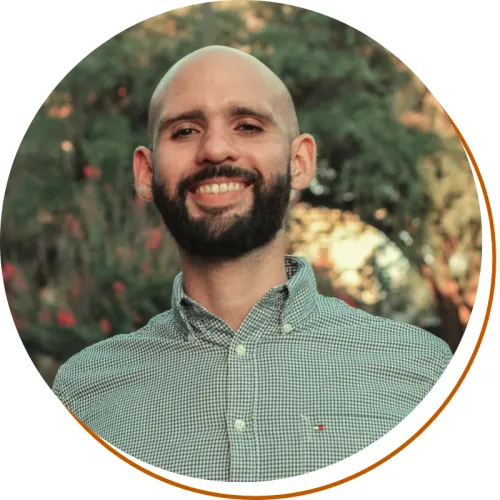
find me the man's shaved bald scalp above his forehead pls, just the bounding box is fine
[148,45,299,149]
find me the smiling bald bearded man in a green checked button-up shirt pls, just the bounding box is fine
[54,47,451,481]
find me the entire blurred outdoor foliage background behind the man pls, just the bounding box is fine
[1,1,481,384]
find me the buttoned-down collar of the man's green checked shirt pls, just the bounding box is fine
[172,255,319,336]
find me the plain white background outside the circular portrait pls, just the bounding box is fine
[0,0,500,500]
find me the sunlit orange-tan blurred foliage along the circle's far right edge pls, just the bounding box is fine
[416,134,482,350]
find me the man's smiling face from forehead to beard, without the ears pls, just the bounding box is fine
[153,55,291,258]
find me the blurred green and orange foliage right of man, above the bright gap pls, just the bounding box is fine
[243,2,481,350]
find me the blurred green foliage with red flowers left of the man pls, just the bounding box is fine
[1,5,250,383]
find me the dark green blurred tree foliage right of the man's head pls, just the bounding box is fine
[250,3,439,253]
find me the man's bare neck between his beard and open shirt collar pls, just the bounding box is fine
[180,231,287,331]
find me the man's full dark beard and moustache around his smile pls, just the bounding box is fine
[153,161,291,260]
